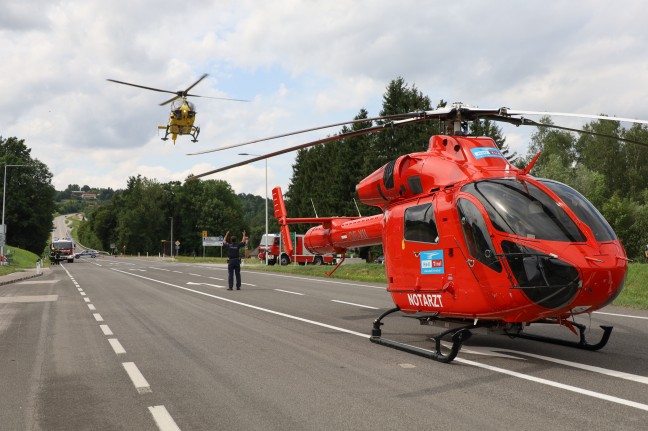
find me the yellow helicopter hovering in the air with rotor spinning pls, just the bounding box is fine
[107,73,249,145]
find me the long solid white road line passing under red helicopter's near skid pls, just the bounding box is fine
[113,269,648,411]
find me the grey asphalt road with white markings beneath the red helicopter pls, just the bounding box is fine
[0,257,648,431]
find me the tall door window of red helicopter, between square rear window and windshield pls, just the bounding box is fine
[457,199,502,272]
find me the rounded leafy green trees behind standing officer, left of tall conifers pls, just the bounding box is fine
[78,175,278,256]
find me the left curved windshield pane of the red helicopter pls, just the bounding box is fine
[462,178,585,242]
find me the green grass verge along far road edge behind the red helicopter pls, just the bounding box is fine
[178,256,648,310]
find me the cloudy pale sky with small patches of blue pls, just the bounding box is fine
[0,0,648,196]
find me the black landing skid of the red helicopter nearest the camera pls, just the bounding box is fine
[370,307,472,363]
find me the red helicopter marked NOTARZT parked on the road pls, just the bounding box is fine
[190,104,648,362]
